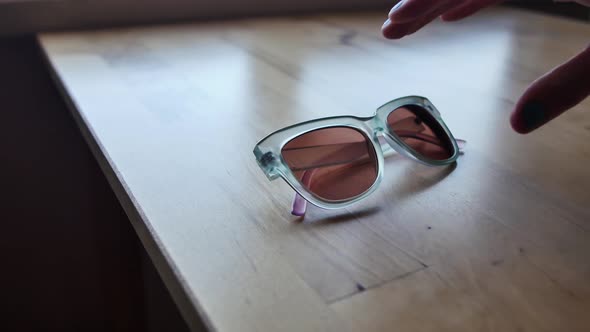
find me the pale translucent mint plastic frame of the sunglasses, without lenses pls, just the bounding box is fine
[254,96,460,215]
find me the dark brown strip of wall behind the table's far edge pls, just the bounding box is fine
[0,0,395,35]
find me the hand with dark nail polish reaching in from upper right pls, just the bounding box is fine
[382,0,590,134]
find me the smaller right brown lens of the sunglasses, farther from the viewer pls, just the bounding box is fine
[387,105,455,160]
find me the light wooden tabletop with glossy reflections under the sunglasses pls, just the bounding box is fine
[40,9,590,331]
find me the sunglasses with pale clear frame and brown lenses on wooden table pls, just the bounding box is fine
[254,96,465,216]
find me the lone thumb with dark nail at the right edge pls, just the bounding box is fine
[510,47,590,134]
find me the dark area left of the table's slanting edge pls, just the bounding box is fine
[0,36,188,331]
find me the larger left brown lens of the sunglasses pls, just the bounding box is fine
[281,127,377,201]
